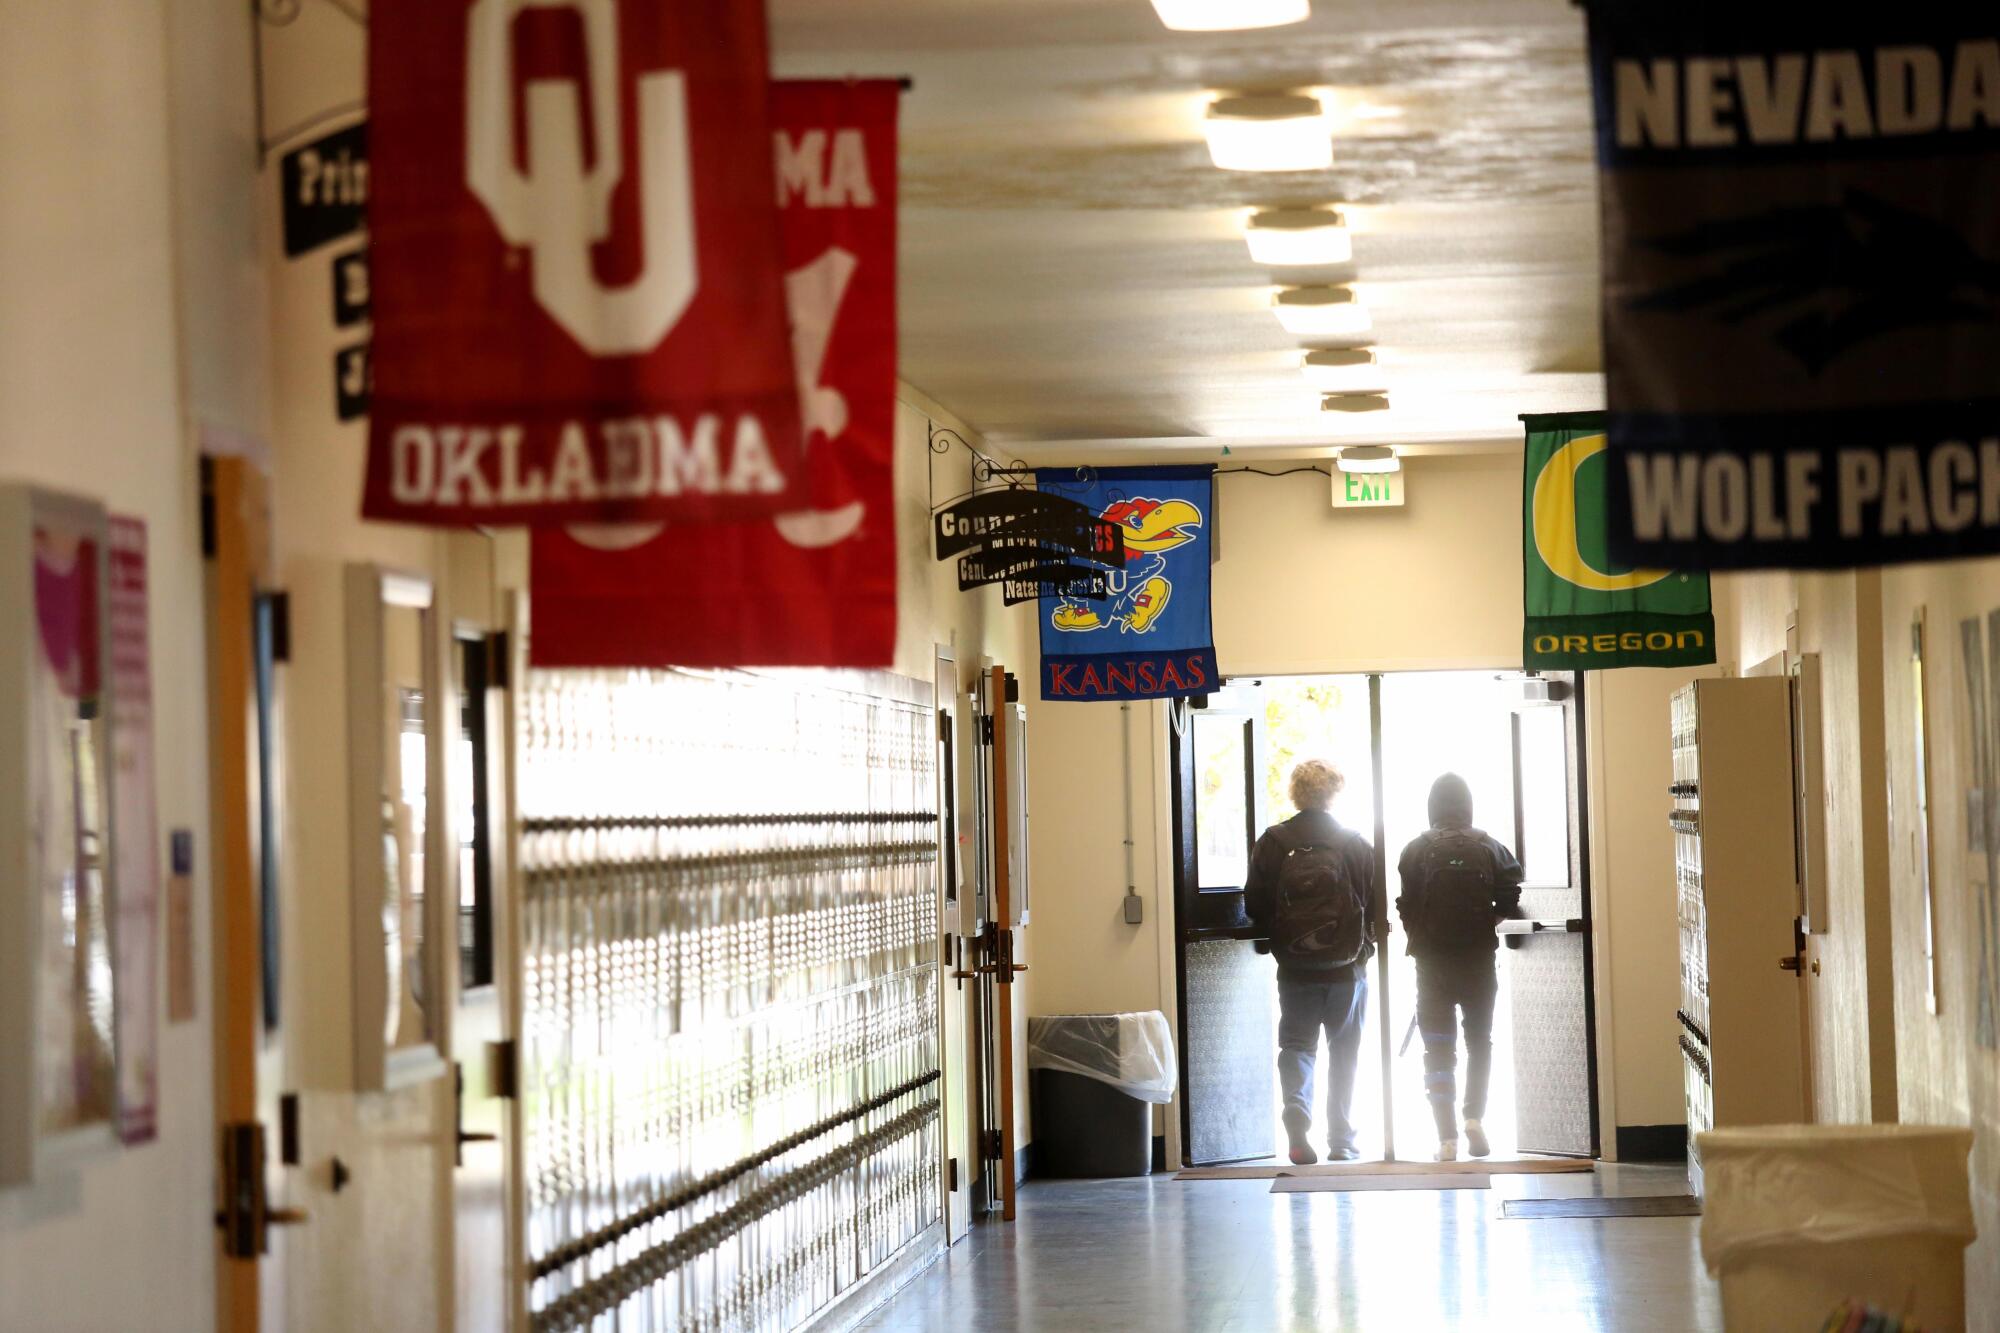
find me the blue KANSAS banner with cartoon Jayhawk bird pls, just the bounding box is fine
[1034,466,1222,701]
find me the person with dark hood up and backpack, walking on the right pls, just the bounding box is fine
[1396,773,1522,1161]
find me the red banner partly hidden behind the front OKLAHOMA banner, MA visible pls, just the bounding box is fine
[528,82,900,667]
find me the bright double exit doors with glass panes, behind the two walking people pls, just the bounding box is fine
[1174,671,1596,1163]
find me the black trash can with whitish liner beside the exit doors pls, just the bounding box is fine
[1028,1011,1178,1179]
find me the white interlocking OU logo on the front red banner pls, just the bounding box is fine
[466,0,698,356]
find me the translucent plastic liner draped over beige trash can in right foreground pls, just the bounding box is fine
[1696,1125,1976,1275]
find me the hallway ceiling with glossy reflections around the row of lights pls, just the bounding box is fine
[772,0,1602,460]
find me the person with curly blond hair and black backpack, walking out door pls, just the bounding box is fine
[1244,759,1382,1167]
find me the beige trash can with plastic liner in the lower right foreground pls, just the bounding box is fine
[1696,1125,1976,1333]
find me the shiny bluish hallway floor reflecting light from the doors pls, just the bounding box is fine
[862,1167,1722,1333]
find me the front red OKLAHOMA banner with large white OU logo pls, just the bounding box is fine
[362,0,800,524]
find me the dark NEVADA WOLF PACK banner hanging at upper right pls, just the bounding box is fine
[1588,13,2000,568]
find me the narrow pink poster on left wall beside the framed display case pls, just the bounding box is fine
[106,516,160,1143]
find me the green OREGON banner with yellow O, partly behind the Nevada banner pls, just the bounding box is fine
[1522,412,1716,671]
